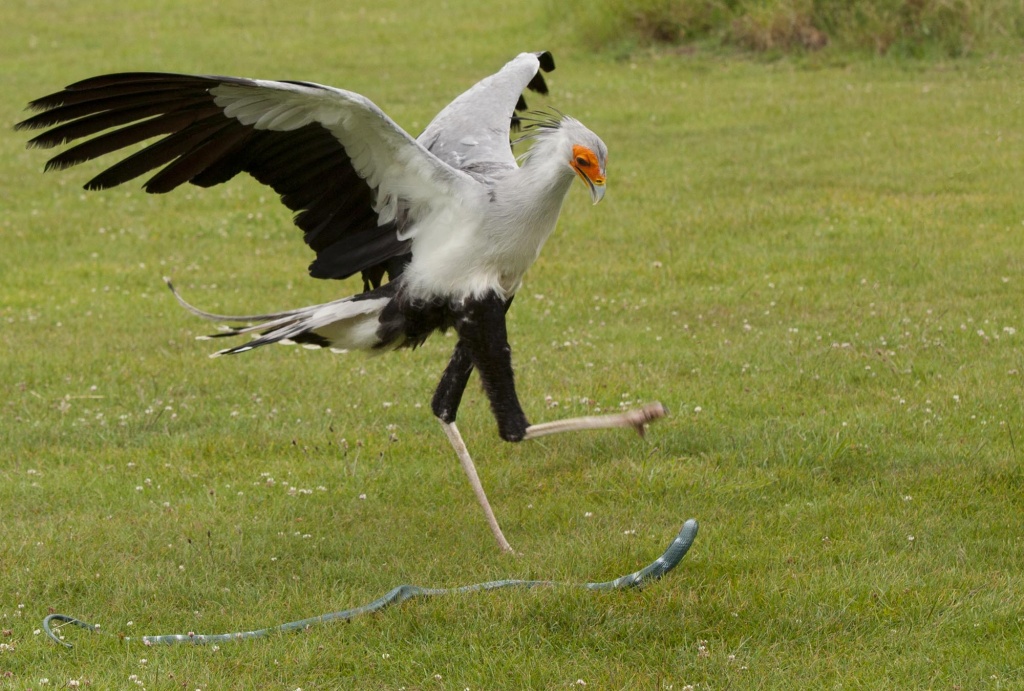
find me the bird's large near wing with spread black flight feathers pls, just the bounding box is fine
[15,73,476,283]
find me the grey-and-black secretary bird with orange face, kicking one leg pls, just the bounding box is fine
[15,52,665,551]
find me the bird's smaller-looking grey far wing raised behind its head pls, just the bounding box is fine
[419,51,555,176]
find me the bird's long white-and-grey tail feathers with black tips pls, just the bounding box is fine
[164,277,389,357]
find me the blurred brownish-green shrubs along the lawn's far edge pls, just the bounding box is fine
[559,0,1024,57]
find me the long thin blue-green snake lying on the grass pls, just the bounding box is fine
[43,518,697,648]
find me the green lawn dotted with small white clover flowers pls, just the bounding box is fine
[0,0,1024,690]
